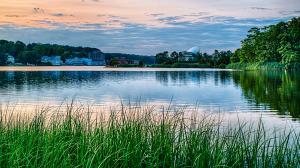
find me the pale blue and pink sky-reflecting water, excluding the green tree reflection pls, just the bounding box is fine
[0,69,299,128]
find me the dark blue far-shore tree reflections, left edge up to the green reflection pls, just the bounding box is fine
[0,71,231,91]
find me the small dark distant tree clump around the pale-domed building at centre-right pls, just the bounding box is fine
[155,50,233,68]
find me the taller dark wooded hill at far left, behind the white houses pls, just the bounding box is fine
[0,40,100,65]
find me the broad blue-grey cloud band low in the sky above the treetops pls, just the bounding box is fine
[0,17,279,55]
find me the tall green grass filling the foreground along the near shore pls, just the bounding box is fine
[0,107,300,167]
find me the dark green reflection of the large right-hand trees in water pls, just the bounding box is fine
[233,71,300,118]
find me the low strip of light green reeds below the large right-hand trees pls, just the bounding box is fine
[226,62,300,70]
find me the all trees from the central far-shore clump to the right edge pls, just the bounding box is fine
[156,17,300,69]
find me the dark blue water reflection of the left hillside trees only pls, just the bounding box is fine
[0,71,151,91]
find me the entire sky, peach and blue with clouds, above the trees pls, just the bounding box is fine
[0,0,300,55]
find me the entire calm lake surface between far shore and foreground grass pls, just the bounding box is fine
[0,67,300,127]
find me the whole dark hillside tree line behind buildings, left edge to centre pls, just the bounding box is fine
[0,40,155,66]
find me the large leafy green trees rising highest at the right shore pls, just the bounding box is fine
[231,17,300,68]
